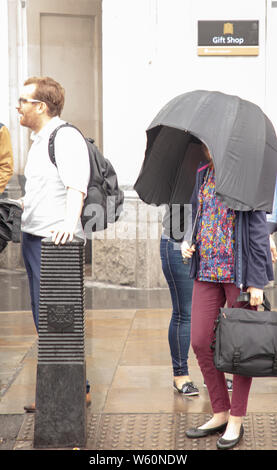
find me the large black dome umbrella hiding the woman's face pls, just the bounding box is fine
[134,90,277,212]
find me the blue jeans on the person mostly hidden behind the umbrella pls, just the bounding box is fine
[160,236,193,377]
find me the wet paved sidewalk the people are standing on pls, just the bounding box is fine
[0,274,277,451]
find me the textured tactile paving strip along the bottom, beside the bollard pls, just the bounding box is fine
[14,413,277,450]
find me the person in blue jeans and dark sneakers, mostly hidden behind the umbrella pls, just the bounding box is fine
[160,206,199,396]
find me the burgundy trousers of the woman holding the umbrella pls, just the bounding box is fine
[191,281,256,416]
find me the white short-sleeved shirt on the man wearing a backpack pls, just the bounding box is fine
[21,116,90,238]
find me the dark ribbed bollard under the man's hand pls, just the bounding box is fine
[34,238,86,448]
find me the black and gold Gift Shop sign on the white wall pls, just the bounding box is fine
[198,20,259,56]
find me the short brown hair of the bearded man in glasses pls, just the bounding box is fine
[24,77,65,117]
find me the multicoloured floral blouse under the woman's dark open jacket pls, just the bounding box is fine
[196,170,235,282]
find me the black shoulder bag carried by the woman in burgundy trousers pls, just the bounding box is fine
[211,213,277,377]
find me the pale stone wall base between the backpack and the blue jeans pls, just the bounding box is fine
[92,194,167,288]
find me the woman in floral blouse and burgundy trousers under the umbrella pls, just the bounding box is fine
[182,144,273,449]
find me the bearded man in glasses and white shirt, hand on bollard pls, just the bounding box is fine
[17,77,90,412]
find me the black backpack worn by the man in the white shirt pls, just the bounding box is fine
[48,123,124,235]
